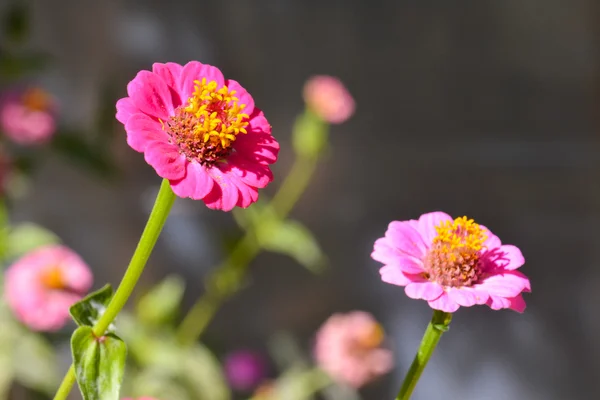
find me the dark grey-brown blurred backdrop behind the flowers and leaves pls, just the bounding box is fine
[2,0,600,400]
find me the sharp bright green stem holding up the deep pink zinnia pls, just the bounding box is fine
[54,179,175,400]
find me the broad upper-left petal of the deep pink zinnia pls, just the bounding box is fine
[127,71,174,121]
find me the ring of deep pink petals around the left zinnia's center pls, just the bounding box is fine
[117,61,279,211]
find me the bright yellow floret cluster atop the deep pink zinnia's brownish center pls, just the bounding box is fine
[185,78,248,149]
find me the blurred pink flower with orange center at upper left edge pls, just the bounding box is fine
[0,87,56,145]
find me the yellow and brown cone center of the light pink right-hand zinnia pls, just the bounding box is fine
[425,217,487,287]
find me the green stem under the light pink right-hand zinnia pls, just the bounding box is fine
[396,310,452,400]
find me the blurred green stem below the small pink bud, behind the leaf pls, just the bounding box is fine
[177,156,317,345]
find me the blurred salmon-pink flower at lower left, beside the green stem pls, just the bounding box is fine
[4,245,92,331]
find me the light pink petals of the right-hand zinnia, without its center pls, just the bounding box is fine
[371,212,531,312]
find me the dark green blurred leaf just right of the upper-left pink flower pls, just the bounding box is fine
[52,131,117,178]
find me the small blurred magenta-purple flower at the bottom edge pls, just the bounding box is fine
[224,350,267,392]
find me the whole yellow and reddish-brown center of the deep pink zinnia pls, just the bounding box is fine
[163,78,249,165]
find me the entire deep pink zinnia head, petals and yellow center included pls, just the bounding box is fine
[117,61,279,211]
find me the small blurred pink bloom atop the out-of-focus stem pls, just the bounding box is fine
[304,75,355,124]
